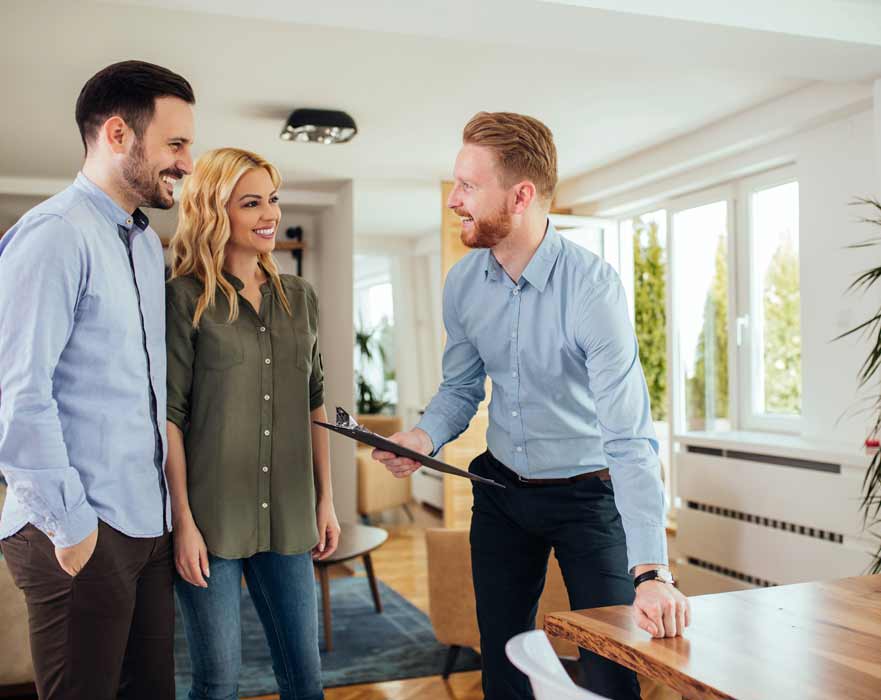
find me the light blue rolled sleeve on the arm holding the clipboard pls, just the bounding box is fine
[416,268,486,453]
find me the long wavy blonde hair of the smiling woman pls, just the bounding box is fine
[171,148,291,328]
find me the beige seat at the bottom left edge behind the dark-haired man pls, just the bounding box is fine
[0,484,34,686]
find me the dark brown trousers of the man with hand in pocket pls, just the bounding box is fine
[0,522,174,700]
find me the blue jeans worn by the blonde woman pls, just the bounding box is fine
[175,552,324,700]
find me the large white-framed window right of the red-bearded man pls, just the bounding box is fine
[620,169,802,436]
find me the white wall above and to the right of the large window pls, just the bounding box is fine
[570,93,881,445]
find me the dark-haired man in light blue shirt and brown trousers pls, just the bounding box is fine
[0,61,195,700]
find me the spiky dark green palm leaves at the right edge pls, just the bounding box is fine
[836,199,881,574]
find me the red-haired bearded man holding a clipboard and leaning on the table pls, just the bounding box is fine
[374,112,691,700]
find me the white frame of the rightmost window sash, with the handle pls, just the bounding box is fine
[729,165,804,434]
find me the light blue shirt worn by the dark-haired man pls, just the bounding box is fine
[0,174,171,547]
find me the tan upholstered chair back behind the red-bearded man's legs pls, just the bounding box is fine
[425,529,578,657]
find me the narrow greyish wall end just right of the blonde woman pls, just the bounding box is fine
[318,182,357,522]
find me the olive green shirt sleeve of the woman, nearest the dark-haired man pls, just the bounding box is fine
[165,283,196,432]
